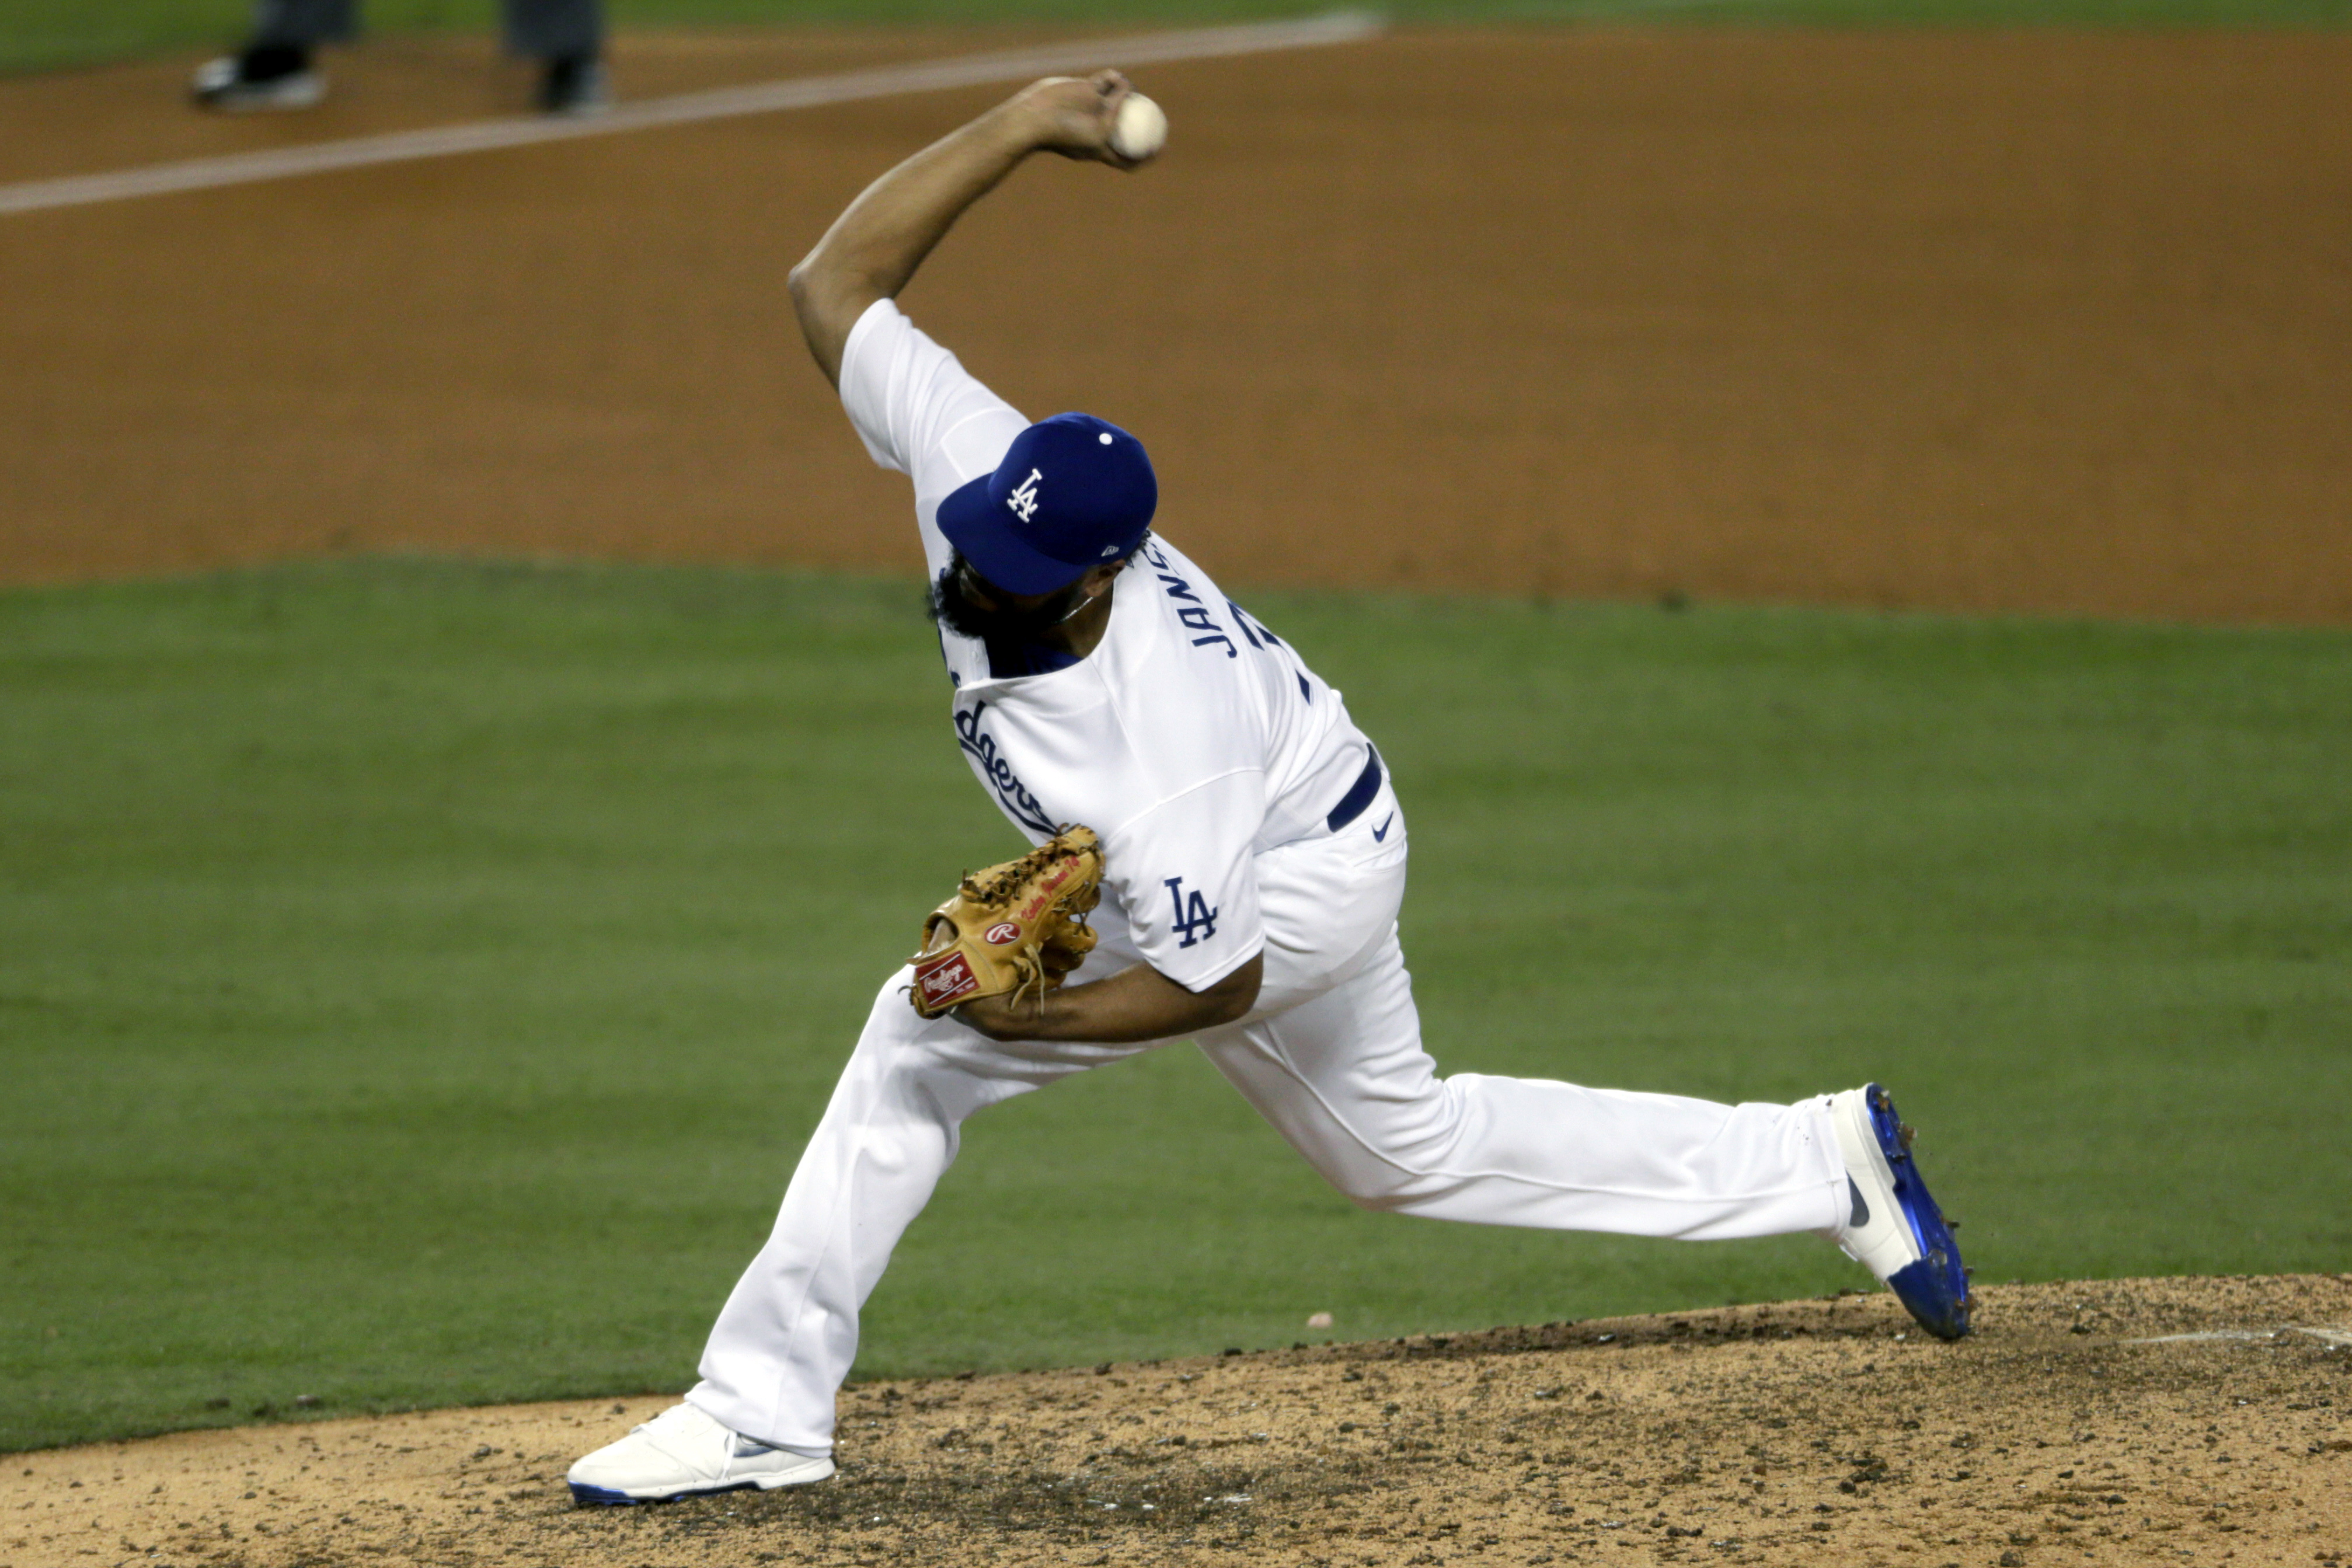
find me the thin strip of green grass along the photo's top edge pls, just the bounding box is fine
[13,0,2352,73]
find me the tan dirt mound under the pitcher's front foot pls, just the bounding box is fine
[0,1274,2352,1568]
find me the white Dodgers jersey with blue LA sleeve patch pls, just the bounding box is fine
[842,298,1378,989]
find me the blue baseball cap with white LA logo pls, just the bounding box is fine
[939,414,1159,595]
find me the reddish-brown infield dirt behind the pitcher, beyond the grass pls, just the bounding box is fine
[0,28,2352,623]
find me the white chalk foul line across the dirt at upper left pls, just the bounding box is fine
[0,12,1383,214]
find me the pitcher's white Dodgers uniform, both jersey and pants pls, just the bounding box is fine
[687,301,1846,1455]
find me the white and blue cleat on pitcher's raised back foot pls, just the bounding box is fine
[1830,1083,1975,1340]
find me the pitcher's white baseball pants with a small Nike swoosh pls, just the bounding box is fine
[687,799,1846,1455]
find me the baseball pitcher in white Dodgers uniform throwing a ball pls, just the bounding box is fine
[569,71,1968,1502]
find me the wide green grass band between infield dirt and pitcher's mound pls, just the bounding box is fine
[0,559,2352,1448]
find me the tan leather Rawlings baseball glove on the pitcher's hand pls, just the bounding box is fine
[908,825,1103,1018]
